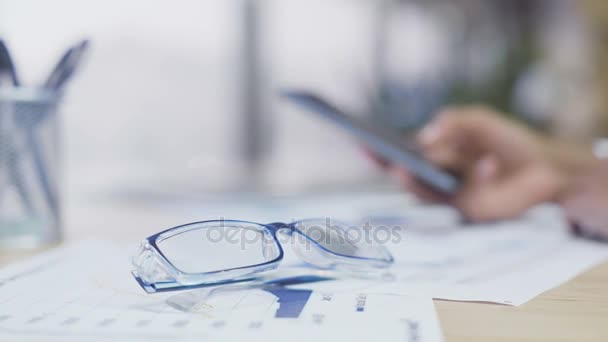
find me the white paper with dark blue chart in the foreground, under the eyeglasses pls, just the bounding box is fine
[0,242,443,342]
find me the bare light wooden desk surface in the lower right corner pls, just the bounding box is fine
[435,263,608,342]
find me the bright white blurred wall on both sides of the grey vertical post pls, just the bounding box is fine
[0,0,394,198]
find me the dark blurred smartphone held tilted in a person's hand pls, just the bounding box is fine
[281,90,461,194]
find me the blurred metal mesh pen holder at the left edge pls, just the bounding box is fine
[0,88,61,249]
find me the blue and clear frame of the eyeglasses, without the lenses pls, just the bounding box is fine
[131,220,394,293]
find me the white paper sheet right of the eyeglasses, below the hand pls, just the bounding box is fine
[298,206,608,305]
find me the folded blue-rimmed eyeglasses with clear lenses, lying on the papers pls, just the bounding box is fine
[131,219,393,293]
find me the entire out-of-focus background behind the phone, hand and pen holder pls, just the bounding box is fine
[0,0,608,197]
